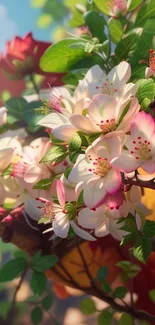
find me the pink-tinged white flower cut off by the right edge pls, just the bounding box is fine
[113,111,155,174]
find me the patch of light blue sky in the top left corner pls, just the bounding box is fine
[0,0,51,51]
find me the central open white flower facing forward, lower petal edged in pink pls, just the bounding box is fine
[68,133,122,208]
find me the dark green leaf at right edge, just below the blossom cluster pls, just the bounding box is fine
[133,235,152,264]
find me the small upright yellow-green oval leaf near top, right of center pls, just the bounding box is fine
[108,18,123,44]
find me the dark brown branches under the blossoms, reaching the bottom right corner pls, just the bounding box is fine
[0,207,155,322]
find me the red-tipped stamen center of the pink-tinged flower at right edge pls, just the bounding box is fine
[130,137,151,160]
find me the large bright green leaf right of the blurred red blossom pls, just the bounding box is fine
[40,39,86,72]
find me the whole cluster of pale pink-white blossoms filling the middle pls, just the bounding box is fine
[0,61,155,241]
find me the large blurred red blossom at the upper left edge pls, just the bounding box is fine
[0,33,62,79]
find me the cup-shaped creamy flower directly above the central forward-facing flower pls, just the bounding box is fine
[70,94,140,134]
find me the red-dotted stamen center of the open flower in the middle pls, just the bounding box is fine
[88,155,111,177]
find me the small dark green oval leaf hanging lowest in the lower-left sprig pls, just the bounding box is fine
[30,272,47,296]
